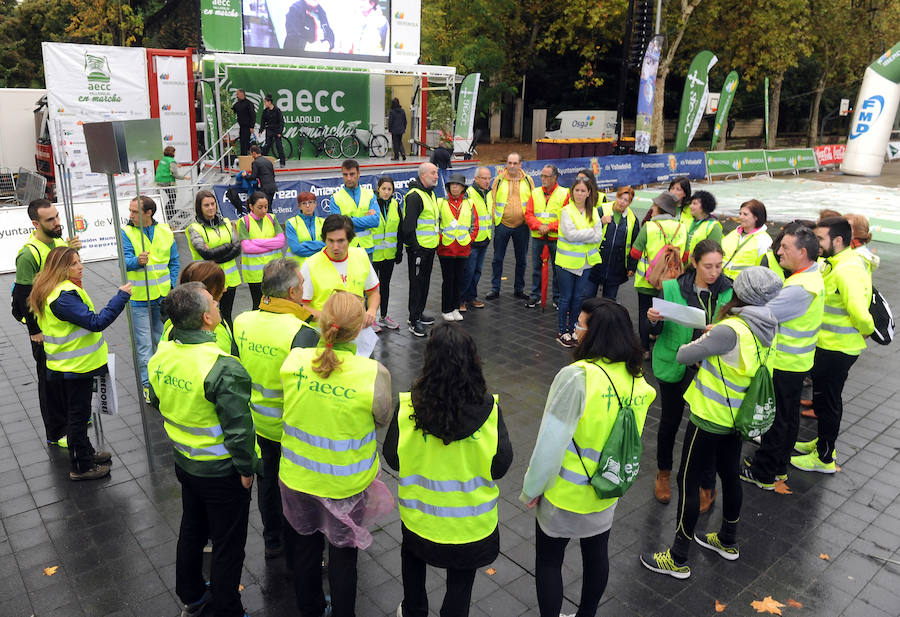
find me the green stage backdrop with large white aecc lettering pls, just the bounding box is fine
[222,65,370,158]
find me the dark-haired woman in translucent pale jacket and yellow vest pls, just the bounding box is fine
[520,298,656,617]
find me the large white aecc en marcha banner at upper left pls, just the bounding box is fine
[41,42,152,200]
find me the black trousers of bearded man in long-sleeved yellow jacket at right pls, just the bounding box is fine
[812,347,859,463]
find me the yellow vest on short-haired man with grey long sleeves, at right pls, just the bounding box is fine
[774,264,825,373]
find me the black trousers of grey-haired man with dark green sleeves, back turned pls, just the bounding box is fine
[175,465,250,617]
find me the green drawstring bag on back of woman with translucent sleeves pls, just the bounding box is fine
[572,365,643,499]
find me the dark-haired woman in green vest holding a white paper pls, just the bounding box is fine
[647,239,732,512]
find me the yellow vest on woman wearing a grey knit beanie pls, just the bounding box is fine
[684,317,774,429]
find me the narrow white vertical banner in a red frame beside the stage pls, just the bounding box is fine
[153,56,195,163]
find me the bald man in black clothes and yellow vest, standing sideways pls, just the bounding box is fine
[400,163,440,337]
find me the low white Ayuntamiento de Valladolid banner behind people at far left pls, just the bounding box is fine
[0,191,166,272]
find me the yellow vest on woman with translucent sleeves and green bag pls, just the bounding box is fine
[544,360,656,514]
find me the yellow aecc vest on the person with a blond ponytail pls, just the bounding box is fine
[278,345,379,499]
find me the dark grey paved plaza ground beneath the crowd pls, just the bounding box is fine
[0,166,900,617]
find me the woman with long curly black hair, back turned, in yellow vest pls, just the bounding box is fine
[382,323,512,617]
